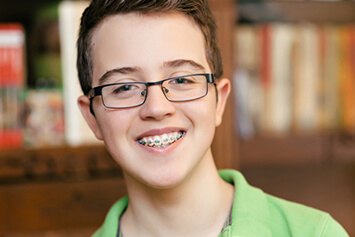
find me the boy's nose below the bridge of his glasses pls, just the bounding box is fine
[140,85,175,121]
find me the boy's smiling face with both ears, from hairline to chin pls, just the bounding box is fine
[78,13,230,188]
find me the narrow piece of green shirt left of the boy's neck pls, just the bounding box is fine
[92,196,128,237]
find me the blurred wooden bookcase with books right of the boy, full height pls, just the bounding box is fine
[233,0,355,236]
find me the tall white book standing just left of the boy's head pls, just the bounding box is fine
[59,1,98,146]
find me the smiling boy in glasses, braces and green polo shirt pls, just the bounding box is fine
[77,0,347,237]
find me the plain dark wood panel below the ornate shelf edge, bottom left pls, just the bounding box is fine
[0,177,126,236]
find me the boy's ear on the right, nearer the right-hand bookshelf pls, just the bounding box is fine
[216,78,231,127]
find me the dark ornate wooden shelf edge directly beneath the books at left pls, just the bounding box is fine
[0,145,122,185]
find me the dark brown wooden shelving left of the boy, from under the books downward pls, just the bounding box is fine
[0,145,126,236]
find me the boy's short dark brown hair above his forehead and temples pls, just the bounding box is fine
[77,0,223,94]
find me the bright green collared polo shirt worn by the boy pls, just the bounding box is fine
[93,170,349,237]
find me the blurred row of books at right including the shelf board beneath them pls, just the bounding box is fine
[233,0,355,165]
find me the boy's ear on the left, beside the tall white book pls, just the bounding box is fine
[78,95,103,140]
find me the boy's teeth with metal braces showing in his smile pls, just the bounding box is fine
[138,131,186,148]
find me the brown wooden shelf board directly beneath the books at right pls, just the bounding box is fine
[238,134,355,167]
